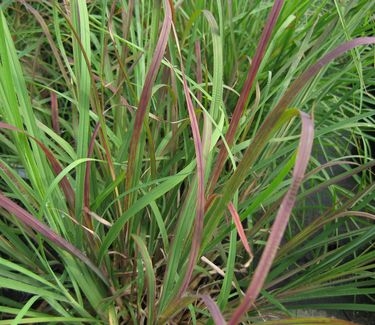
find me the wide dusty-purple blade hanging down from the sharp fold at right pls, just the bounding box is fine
[228,112,314,325]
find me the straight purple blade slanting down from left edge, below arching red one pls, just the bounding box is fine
[0,192,108,284]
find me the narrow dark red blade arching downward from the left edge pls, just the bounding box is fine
[0,122,74,210]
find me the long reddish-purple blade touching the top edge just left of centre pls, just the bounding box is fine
[125,1,172,209]
